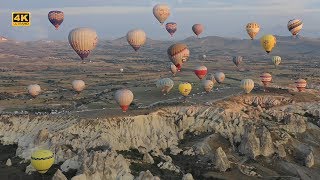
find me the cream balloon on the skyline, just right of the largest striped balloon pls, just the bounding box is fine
[127,29,147,51]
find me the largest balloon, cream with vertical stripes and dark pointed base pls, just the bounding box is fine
[68,28,98,60]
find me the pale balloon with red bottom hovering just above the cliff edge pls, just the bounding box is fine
[114,89,133,112]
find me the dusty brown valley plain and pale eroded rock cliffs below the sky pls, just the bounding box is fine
[0,37,320,180]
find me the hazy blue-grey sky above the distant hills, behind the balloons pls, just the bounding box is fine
[0,0,320,40]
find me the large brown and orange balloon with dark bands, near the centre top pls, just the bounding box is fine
[167,43,190,71]
